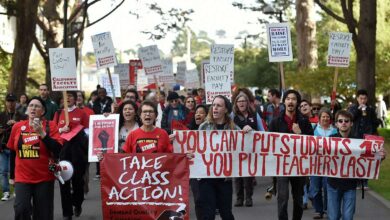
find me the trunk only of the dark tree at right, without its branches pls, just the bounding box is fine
[354,0,377,104]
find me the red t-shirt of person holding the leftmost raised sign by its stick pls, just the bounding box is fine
[54,108,89,130]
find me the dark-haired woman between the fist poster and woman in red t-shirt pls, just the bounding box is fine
[118,100,140,152]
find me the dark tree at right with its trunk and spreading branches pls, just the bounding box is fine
[314,0,377,104]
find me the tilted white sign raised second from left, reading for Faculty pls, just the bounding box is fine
[91,32,118,69]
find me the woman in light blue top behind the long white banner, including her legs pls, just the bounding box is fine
[310,108,337,219]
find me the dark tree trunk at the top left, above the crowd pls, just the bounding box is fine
[9,0,39,96]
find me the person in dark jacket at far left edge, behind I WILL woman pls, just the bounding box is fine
[0,93,24,201]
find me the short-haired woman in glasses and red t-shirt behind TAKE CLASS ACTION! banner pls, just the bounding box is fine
[123,100,173,153]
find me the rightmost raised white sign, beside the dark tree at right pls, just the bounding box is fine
[326,32,352,67]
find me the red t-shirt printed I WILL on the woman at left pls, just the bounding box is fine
[7,120,63,183]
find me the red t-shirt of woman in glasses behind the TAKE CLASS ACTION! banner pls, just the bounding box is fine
[123,127,173,153]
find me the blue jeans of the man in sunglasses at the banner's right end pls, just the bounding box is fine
[327,184,356,220]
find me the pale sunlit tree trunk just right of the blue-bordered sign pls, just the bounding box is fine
[296,0,318,70]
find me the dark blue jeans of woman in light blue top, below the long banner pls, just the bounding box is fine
[309,176,327,214]
